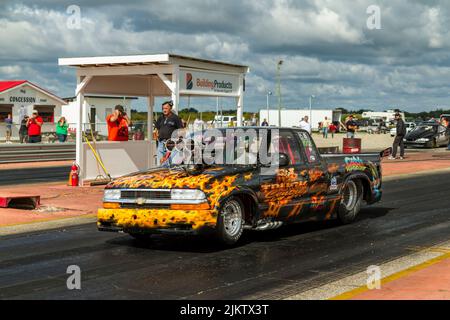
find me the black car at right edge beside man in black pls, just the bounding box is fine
[403,121,450,148]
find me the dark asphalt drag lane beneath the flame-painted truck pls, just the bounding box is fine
[0,173,450,299]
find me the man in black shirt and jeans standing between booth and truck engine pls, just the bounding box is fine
[155,101,183,164]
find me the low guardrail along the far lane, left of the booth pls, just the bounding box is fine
[0,143,75,163]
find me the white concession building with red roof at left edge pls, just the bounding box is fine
[0,80,65,140]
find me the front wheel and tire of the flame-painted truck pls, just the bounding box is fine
[216,197,245,246]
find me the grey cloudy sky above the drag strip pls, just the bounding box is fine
[0,0,450,111]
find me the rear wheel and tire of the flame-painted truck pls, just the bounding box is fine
[337,179,363,224]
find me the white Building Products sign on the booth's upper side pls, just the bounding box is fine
[180,69,239,96]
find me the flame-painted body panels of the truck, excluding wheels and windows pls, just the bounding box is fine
[98,132,381,235]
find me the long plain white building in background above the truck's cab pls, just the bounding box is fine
[259,109,342,129]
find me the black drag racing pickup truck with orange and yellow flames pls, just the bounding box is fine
[97,127,390,245]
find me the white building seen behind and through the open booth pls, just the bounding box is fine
[62,95,137,135]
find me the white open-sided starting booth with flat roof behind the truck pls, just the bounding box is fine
[58,54,249,184]
